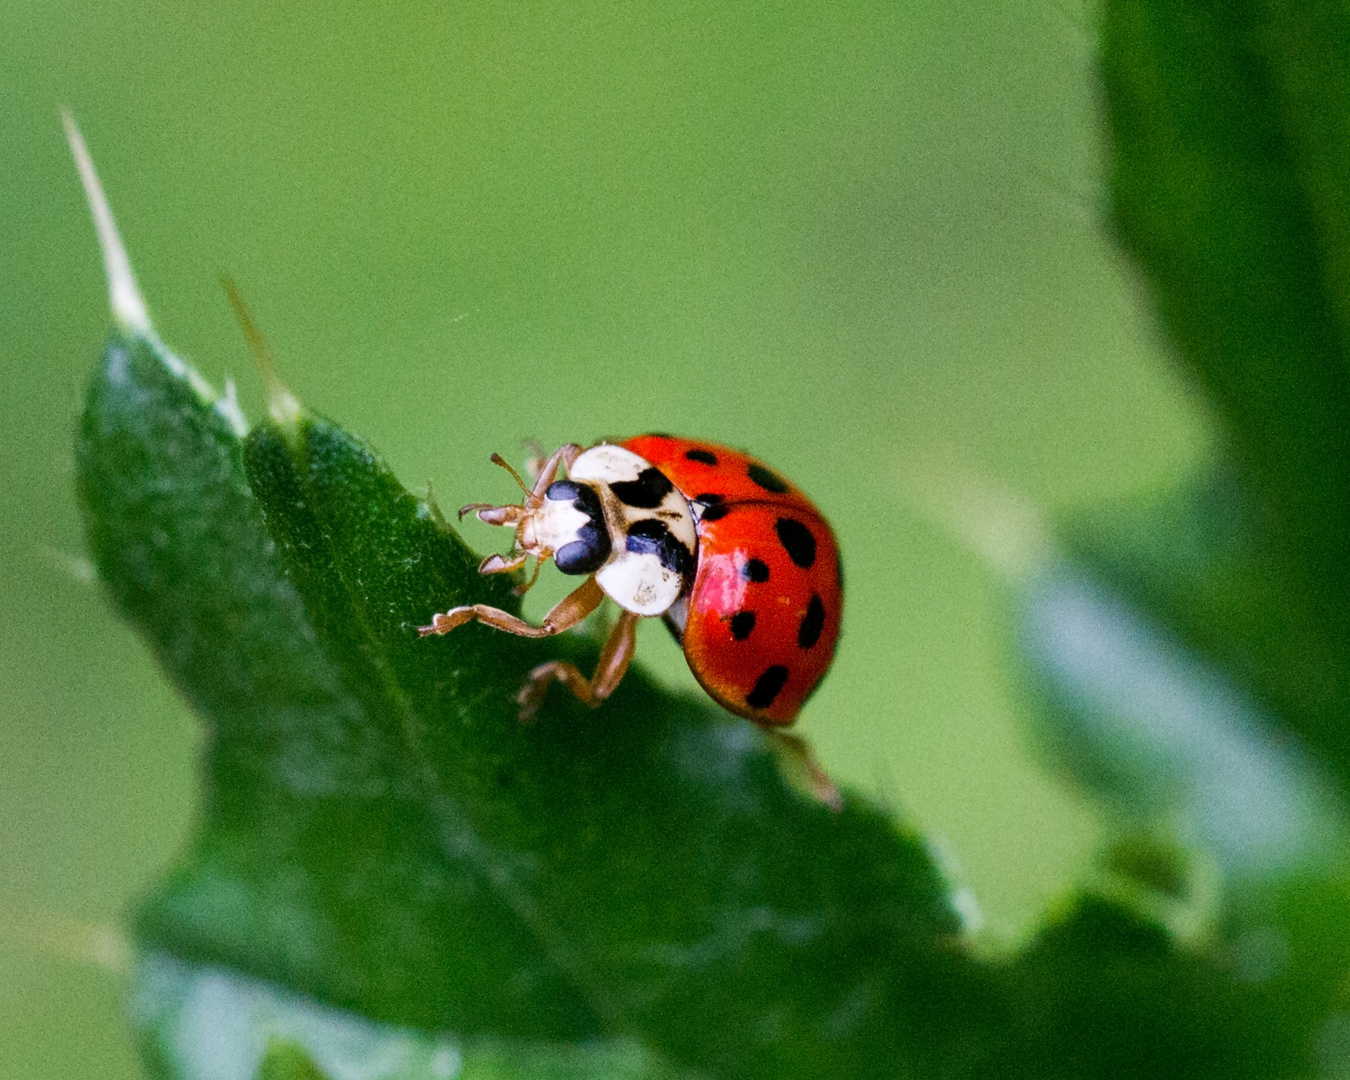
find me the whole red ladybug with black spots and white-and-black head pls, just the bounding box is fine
[419,435,844,729]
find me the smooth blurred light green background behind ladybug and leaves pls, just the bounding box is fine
[0,0,1211,1077]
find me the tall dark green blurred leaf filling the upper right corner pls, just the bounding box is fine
[1102,0,1350,623]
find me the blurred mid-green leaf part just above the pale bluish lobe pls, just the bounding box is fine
[1033,470,1350,815]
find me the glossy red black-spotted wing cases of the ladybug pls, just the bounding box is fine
[622,435,844,726]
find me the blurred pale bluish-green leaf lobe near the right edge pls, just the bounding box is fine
[1018,533,1346,878]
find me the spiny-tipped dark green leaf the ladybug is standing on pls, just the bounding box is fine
[80,330,961,1076]
